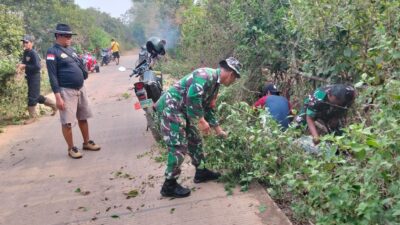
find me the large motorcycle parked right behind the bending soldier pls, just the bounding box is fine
[119,58,163,141]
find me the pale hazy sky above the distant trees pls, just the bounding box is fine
[75,0,132,17]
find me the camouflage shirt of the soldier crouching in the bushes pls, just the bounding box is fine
[303,85,346,122]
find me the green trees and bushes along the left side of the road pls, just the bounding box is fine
[0,0,133,122]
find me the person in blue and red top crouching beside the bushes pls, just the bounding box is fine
[254,83,291,129]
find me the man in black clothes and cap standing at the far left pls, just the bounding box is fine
[18,35,57,124]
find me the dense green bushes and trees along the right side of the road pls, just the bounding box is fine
[154,0,400,224]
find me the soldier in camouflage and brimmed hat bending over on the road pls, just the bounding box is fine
[155,57,241,197]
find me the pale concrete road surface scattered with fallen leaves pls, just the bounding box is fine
[0,55,290,225]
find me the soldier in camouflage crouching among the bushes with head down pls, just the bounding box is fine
[297,84,355,144]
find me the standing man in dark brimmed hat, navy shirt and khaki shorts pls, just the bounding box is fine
[46,24,100,159]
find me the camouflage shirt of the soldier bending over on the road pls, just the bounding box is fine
[156,68,221,127]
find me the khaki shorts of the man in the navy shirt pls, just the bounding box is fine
[60,86,92,124]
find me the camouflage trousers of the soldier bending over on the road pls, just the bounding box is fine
[160,107,204,179]
